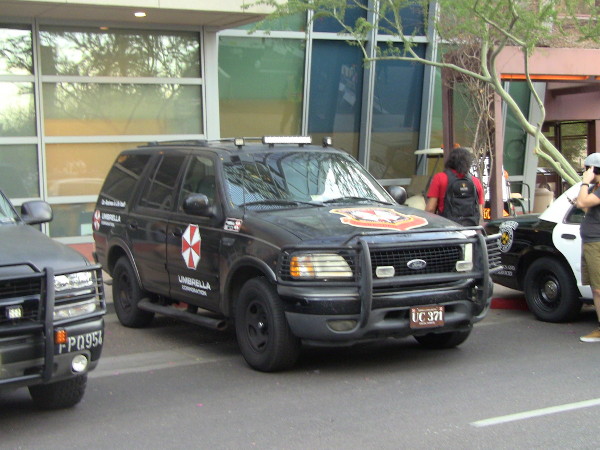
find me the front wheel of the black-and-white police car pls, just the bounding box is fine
[523,257,582,322]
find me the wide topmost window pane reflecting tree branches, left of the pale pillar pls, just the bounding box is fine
[40,27,201,78]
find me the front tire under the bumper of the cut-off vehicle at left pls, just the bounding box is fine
[29,375,87,409]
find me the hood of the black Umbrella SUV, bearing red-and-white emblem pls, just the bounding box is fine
[246,203,458,243]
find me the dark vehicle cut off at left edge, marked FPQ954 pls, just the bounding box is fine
[0,188,106,408]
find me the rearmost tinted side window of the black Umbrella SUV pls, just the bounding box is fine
[102,155,150,202]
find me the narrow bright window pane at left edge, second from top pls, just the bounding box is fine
[0,82,36,137]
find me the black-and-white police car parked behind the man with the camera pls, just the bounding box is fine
[486,183,592,322]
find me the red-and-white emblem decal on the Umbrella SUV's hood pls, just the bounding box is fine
[329,208,428,231]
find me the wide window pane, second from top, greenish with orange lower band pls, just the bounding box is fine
[43,83,203,136]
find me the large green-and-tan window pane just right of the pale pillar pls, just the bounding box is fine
[219,37,304,137]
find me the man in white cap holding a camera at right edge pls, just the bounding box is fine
[576,153,600,342]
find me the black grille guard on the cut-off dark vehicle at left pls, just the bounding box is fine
[0,262,106,386]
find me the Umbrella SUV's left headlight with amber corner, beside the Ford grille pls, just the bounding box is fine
[290,253,352,279]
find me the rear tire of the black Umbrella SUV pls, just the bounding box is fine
[113,256,154,328]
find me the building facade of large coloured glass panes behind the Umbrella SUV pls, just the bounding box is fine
[0,0,596,251]
